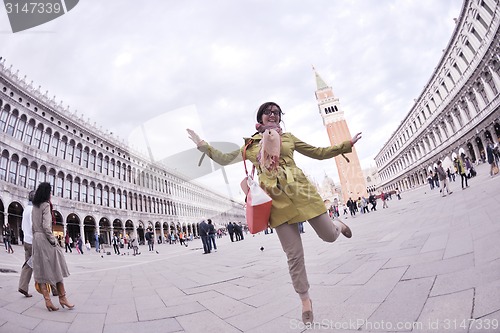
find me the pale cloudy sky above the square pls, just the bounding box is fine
[0,0,462,198]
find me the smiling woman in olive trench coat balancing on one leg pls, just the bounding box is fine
[187,102,361,324]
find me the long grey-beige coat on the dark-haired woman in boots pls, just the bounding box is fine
[31,202,69,286]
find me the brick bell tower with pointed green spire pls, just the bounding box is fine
[313,67,368,203]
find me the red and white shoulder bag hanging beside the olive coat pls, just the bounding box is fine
[241,142,273,234]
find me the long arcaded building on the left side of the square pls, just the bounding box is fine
[0,60,244,245]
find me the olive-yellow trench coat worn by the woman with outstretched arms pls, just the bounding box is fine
[198,133,352,228]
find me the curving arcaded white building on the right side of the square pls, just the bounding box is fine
[375,0,500,191]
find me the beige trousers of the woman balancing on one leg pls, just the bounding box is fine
[276,213,340,300]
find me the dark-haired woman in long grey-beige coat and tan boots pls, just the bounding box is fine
[31,183,74,311]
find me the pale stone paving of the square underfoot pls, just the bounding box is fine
[0,165,500,333]
